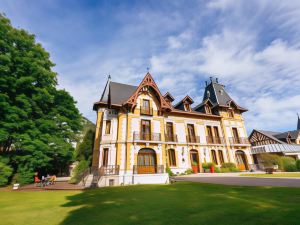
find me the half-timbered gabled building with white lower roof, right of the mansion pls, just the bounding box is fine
[249,116,300,165]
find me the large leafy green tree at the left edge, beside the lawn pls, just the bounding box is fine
[0,14,81,183]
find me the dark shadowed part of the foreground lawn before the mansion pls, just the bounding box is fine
[61,183,300,225]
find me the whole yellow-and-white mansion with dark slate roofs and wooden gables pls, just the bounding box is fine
[93,73,252,186]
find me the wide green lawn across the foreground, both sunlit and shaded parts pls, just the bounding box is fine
[0,183,300,225]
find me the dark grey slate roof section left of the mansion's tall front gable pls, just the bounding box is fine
[100,81,138,105]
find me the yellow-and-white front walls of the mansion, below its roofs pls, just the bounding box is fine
[93,74,252,179]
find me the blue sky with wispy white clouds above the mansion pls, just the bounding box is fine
[0,0,300,131]
